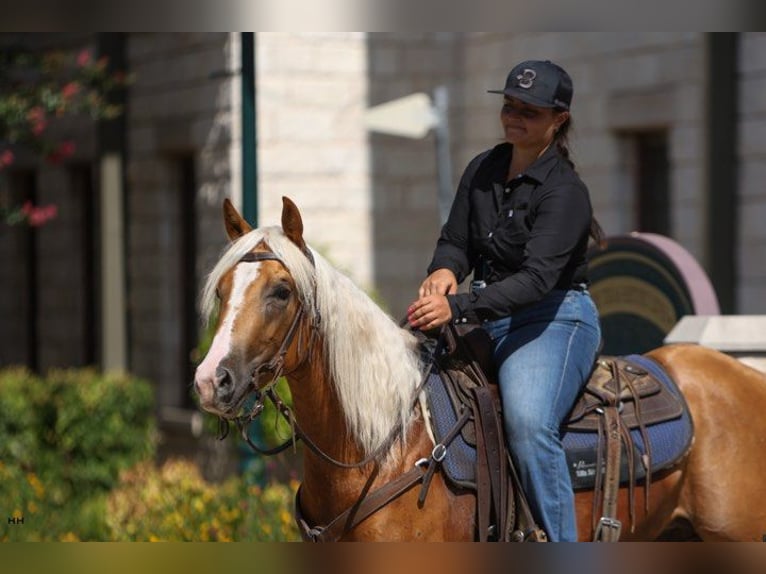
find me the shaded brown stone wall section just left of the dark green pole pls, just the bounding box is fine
[126,33,241,405]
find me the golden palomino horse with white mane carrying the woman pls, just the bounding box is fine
[195,198,766,541]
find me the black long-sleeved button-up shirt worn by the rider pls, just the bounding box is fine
[428,143,592,322]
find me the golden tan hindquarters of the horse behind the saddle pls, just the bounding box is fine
[650,345,766,540]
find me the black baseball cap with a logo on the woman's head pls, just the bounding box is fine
[487,60,573,110]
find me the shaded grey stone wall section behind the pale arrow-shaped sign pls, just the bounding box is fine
[368,32,463,319]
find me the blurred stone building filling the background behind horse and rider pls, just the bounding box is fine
[0,32,766,454]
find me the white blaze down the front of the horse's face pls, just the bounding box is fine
[194,262,261,403]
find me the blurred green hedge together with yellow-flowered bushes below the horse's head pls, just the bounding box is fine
[0,368,299,541]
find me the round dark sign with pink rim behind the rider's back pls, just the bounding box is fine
[588,233,720,355]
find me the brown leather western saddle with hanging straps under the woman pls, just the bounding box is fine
[426,325,685,541]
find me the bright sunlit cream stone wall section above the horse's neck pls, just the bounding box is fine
[256,32,373,288]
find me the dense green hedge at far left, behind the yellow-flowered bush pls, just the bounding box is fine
[0,368,155,540]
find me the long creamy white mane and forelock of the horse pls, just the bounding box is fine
[201,227,421,460]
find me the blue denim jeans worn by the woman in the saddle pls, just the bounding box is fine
[483,290,601,541]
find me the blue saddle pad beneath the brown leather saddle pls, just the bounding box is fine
[426,355,694,496]
